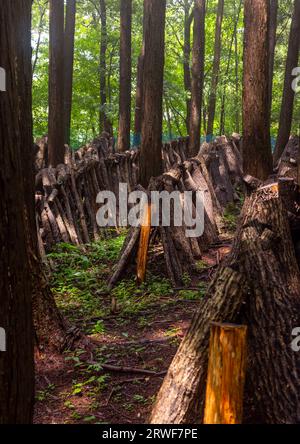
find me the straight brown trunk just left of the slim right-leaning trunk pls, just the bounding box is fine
[189,0,205,157]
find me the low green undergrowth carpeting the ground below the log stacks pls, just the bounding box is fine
[48,234,205,335]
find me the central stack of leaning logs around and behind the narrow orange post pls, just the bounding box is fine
[109,137,243,288]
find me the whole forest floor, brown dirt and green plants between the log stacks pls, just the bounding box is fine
[35,210,237,424]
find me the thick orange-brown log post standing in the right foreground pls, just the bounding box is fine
[204,323,247,424]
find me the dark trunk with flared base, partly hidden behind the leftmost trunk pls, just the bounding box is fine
[25,2,74,351]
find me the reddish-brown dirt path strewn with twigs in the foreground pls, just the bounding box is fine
[35,243,230,424]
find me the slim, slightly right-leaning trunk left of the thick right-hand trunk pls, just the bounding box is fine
[207,0,224,135]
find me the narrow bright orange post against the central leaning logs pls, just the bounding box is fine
[137,204,151,283]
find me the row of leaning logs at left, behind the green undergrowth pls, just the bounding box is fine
[36,138,138,255]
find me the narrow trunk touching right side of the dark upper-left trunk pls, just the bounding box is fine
[64,0,76,145]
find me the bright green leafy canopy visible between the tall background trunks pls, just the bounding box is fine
[32,0,300,148]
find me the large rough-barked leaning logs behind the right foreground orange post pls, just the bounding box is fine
[151,180,300,424]
